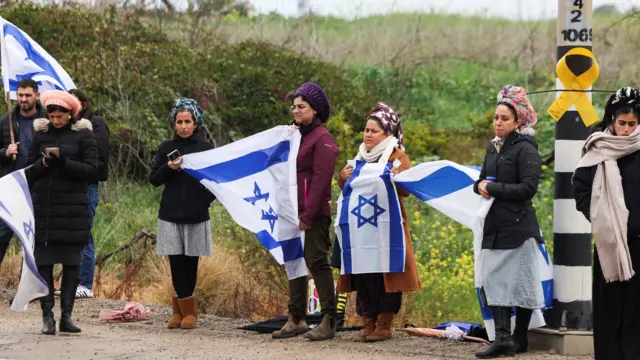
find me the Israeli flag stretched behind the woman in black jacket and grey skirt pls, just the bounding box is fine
[393,160,553,340]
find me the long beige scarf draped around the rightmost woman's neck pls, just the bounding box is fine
[578,128,640,282]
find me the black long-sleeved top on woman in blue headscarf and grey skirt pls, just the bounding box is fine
[151,135,215,224]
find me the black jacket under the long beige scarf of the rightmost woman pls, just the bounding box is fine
[573,151,640,240]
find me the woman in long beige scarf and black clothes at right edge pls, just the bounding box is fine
[573,88,640,360]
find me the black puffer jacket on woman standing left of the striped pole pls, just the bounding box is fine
[473,132,542,249]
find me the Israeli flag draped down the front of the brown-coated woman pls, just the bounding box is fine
[335,160,406,274]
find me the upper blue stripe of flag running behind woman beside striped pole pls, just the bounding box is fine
[397,166,474,201]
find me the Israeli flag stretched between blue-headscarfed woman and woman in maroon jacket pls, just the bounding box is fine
[182,126,308,279]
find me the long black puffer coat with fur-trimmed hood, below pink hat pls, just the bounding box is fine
[25,119,98,246]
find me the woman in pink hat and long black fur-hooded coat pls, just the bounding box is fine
[25,90,98,335]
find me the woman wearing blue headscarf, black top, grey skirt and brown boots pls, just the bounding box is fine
[151,98,215,329]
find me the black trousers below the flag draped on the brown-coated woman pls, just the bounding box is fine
[351,273,402,319]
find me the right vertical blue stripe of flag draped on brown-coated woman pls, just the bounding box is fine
[380,164,406,272]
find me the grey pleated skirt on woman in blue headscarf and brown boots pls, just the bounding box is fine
[156,219,213,256]
